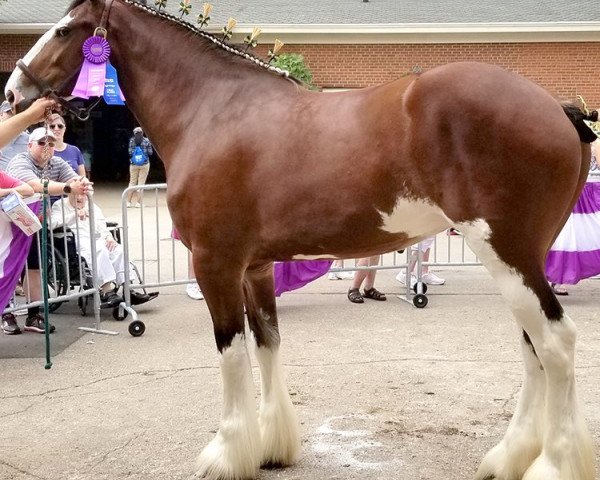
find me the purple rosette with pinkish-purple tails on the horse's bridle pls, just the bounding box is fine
[71,35,110,98]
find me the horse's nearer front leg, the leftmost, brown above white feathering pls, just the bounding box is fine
[194,253,261,480]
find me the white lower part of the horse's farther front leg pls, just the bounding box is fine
[256,346,300,465]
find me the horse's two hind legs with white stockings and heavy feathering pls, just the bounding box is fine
[458,222,594,480]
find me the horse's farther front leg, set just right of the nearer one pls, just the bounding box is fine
[244,264,300,465]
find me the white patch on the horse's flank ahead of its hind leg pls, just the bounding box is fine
[379,197,452,237]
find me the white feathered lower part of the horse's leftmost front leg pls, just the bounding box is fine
[196,334,261,479]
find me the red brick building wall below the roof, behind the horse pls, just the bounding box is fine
[0,35,600,108]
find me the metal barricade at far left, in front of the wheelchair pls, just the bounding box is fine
[3,194,111,334]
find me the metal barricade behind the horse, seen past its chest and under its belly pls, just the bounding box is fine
[121,183,488,312]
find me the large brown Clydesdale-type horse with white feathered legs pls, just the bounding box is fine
[6,0,595,480]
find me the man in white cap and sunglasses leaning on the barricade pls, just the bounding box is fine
[7,127,93,333]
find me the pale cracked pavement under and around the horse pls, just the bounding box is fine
[0,182,600,480]
